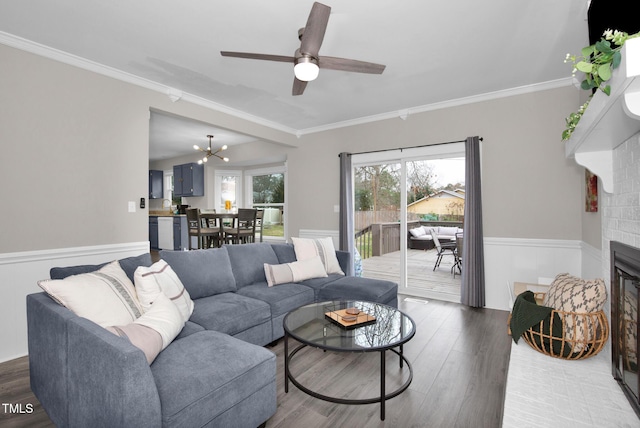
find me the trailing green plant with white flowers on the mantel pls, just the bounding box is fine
[562,30,640,141]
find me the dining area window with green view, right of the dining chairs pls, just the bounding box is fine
[245,166,286,240]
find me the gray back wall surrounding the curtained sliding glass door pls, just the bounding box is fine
[288,87,584,240]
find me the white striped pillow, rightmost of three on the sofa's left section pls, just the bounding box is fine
[133,260,193,322]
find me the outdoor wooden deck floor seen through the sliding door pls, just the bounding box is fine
[362,249,461,302]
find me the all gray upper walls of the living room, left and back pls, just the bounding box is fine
[0,42,595,253]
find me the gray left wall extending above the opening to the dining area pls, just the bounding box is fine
[0,45,297,253]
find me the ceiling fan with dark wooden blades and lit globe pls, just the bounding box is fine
[220,2,385,95]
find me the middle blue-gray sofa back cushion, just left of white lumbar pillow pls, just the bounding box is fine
[224,242,279,289]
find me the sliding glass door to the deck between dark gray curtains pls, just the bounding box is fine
[352,143,464,302]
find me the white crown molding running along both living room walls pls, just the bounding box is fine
[0,31,573,138]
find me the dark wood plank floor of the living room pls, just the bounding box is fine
[0,296,511,428]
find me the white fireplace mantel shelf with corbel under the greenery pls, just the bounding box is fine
[565,38,640,193]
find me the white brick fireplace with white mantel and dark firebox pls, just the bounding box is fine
[565,39,640,415]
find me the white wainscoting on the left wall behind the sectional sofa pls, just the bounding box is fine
[0,241,149,362]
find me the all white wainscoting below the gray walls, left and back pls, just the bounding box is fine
[0,236,608,362]
